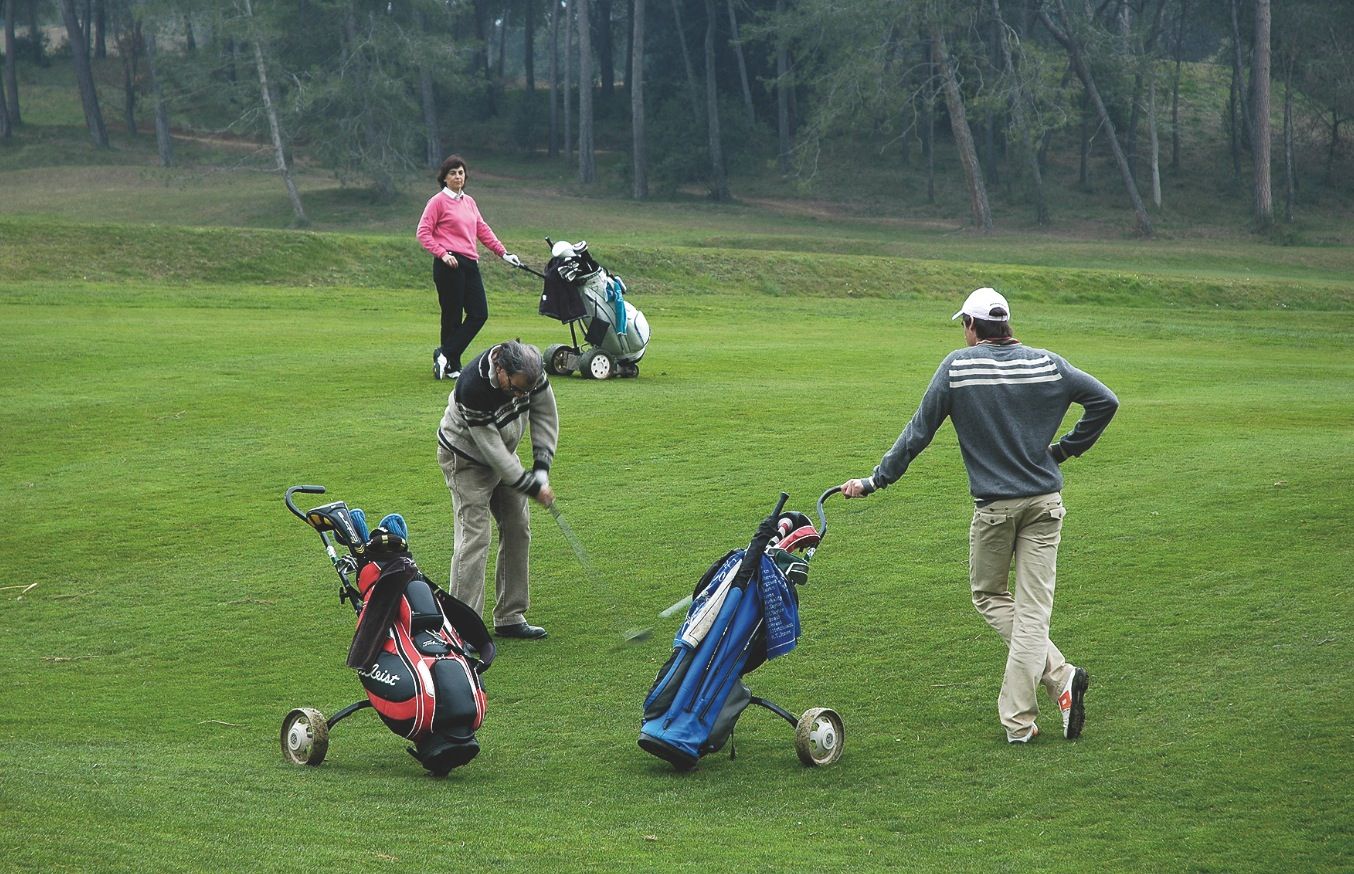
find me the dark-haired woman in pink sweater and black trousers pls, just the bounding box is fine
[417,154,521,379]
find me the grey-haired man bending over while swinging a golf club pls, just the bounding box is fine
[437,340,559,640]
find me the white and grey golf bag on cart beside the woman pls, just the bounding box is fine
[540,240,649,379]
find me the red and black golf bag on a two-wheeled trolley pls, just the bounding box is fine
[282,485,494,776]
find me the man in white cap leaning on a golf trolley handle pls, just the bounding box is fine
[842,289,1118,744]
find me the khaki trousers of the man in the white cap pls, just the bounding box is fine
[968,492,1072,740]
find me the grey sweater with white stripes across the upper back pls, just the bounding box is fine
[865,343,1118,503]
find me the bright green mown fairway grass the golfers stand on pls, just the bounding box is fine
[0,269,1354,871]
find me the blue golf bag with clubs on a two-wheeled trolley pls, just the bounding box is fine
[639,489,842,771]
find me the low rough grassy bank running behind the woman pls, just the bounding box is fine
[0,218,1354,310]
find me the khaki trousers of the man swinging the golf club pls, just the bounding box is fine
[437,446,531,626]
